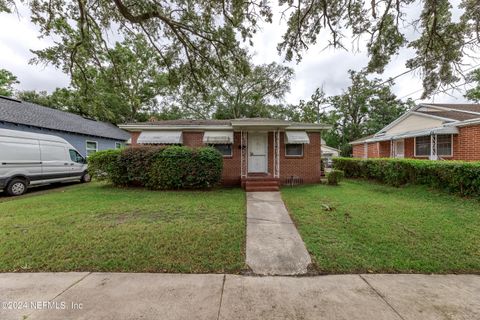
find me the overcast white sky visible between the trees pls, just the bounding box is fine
[0,1,479,103]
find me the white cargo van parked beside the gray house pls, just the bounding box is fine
[0,129,90,196]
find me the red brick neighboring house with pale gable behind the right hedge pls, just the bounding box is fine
[350,104,480,161]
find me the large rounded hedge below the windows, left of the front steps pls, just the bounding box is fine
[88,146,223,189]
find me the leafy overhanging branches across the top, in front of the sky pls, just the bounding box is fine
[0,0,472,107]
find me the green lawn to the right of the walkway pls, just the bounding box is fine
[282,180,480,273]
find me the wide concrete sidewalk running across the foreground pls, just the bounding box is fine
[0,273,480,320]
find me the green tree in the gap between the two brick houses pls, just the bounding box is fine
[284,70,413,156]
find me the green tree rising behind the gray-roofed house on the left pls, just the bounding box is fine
[30,36,173,123]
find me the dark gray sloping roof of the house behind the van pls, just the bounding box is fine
[0,96,130,141]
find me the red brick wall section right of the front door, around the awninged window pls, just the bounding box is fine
[280,132,321,183]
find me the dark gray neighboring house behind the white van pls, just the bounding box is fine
[0,96,130,157]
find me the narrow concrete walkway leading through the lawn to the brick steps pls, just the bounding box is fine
[246,192,311,275]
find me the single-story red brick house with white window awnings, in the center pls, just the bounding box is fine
[120,118,328,191]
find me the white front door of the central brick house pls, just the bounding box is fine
[248,132,268,173]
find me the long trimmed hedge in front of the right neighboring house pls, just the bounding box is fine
[333,158,480,196]
